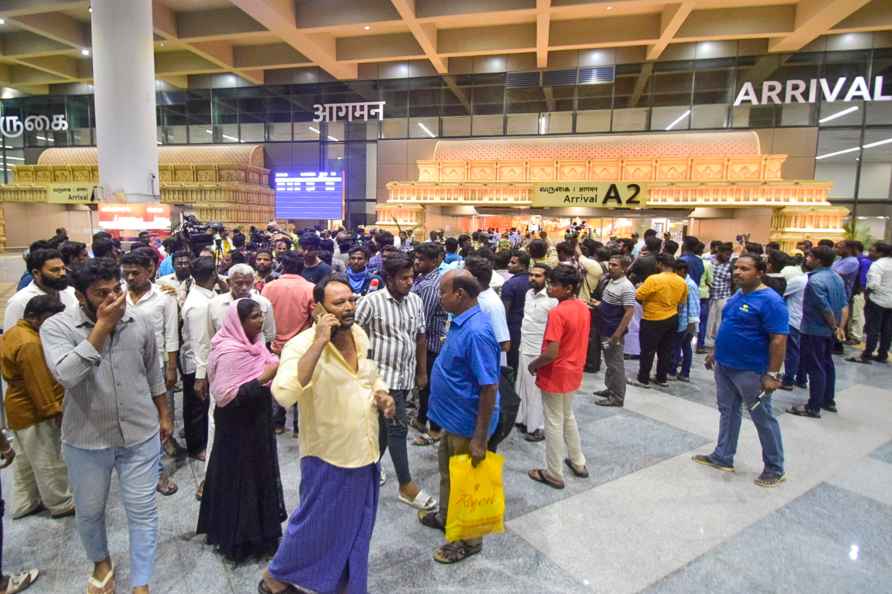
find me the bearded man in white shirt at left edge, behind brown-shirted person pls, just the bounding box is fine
[3,249,80,332]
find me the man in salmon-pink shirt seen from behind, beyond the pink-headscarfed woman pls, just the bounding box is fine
[261,247,315,437]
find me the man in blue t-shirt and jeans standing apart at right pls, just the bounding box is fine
[693,254,789,487]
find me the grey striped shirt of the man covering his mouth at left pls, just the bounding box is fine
[40,308,167,450]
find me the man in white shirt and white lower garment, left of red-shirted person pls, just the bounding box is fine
[515,264,558,441]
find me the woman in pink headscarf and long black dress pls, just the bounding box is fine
[196,299,287,562]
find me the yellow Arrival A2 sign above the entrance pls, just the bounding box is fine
[530,182,650,209]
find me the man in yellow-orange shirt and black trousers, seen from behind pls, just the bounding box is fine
[631,254,688,388]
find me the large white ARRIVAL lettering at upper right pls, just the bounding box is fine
[734,76,892,106]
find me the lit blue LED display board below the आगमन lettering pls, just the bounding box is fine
[273,171,344,220]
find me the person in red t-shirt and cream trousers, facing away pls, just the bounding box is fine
[528,264,591,489]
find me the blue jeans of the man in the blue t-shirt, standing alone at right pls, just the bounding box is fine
[710,363,784,474]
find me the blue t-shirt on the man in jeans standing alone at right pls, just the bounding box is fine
[715,288,790,374]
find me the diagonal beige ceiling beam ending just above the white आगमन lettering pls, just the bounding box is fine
[230,0,359,79]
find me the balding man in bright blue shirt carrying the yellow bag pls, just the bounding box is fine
[418,270,500,563]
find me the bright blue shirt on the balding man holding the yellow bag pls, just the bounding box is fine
[427,305,500,439]
